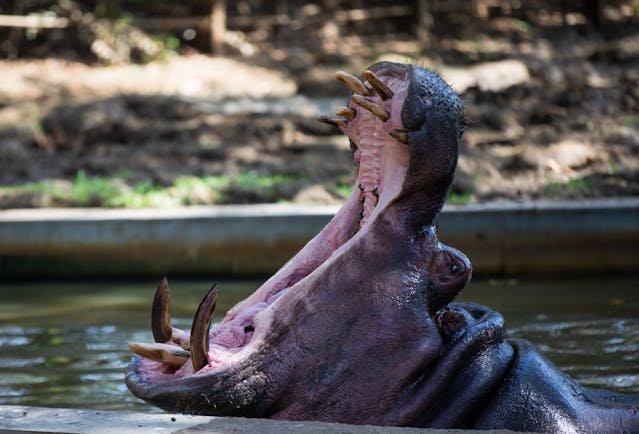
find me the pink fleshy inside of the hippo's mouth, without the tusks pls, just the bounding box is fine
[139,70,408,382]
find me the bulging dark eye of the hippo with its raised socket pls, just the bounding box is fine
[428,245,472,314]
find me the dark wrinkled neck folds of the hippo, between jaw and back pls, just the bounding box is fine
[384,303,514,428]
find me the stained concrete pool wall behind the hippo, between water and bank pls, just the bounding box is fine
[0,198,639,279]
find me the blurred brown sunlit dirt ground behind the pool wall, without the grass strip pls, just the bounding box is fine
[0,19,639,208]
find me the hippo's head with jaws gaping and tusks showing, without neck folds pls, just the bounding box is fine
[126,62,476,424]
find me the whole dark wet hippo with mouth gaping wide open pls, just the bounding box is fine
[126,62,639,432]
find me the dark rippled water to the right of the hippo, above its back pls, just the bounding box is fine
[461,278,639,392]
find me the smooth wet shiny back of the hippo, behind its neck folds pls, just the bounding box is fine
[473,339,639,433]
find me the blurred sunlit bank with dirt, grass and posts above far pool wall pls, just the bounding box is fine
[0,0,639,208]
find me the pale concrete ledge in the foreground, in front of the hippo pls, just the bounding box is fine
[0,405,512,434]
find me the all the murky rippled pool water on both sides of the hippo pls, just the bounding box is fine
[0,278,639,412]
